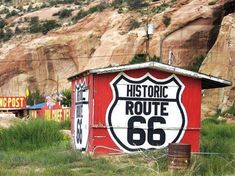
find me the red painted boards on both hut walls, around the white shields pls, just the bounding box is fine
[71,69,201,154]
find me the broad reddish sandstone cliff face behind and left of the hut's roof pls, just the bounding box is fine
[0,0,233,100]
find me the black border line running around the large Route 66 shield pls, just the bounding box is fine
[108,74,185,152]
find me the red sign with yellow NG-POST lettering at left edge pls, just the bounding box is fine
[0,97,26,109]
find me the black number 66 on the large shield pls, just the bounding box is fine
[127,116,166,146]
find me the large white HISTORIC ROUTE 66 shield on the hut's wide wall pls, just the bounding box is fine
[106,73,187,152]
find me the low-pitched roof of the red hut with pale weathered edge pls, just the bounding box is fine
[68,62,232,89]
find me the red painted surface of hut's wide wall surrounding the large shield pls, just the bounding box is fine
[90,69,201,153]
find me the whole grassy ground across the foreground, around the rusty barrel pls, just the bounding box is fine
[0,118,235,176]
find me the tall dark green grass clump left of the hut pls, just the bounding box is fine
[0,119,63,150]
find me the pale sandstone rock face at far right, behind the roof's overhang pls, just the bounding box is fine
[200,13,235,118]
